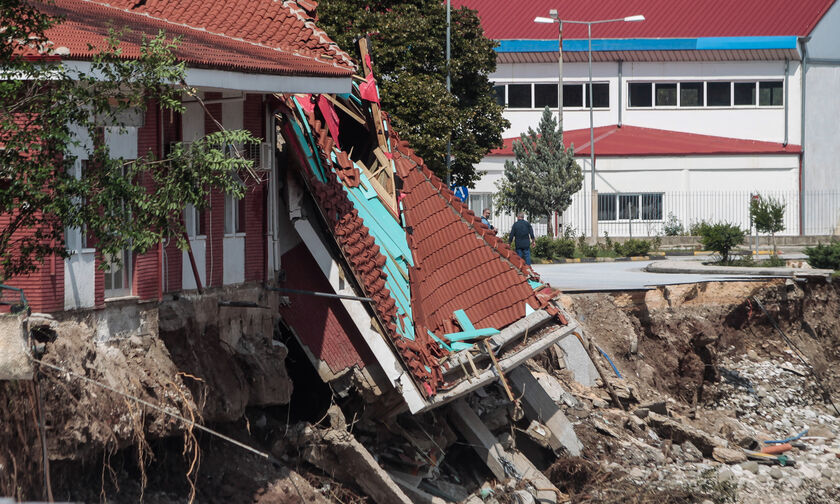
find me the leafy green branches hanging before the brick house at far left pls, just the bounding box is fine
[0,0,257,280]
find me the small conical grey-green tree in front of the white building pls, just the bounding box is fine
[494,107,583,233]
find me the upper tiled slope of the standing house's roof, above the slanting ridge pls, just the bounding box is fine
[87,0,352,68]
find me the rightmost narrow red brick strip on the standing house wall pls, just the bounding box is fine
[243,94,268,282]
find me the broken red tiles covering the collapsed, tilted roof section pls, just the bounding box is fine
[283,96,566,395]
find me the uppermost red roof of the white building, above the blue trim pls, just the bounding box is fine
[453,0,834,40]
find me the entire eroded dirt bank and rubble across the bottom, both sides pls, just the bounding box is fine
[0,280,840,504]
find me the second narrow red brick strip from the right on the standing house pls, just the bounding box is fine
[204,93,225,287]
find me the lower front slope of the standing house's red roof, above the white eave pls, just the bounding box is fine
[39,0,351,77]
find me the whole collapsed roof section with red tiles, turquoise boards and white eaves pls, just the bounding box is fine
[277,41,577,412]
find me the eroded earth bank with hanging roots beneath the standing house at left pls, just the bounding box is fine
[0,289,292,500]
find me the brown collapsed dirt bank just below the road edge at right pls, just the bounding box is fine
[566,279,840,410]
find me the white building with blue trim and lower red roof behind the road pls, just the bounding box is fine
[466,0,840,236]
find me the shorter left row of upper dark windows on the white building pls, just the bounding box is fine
[493,82,610,109]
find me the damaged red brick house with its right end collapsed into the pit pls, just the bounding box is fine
[2,0,612,495]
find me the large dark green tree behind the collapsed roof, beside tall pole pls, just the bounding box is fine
[318,0,510,186]
